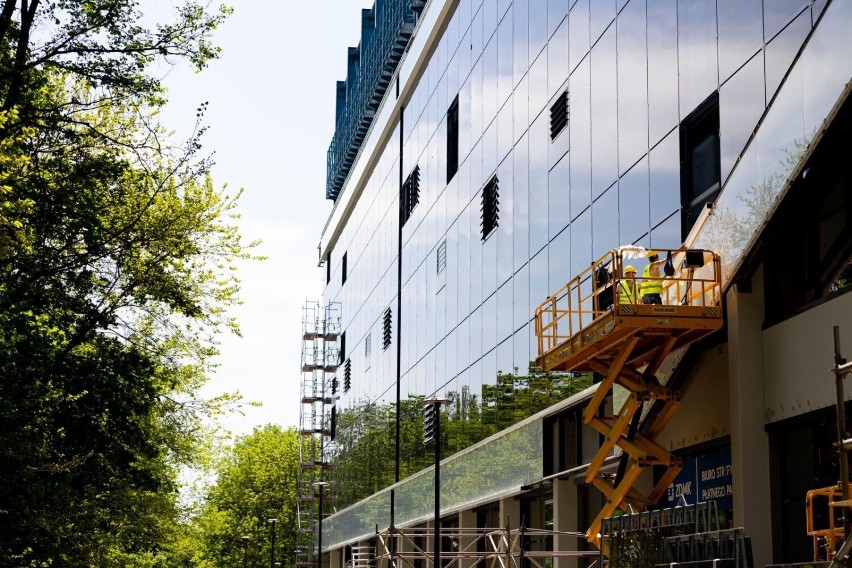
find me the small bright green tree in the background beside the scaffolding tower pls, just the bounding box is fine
[194,425,299,567]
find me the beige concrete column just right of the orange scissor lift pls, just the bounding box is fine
[726,269,772,566]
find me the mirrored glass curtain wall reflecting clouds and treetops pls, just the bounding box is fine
[325,0,832,528]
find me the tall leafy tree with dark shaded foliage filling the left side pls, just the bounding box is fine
[0,0,252,566]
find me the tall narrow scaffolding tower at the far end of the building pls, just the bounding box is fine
[296,301,340,568]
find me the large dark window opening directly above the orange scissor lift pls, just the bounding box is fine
[680,93,722,238]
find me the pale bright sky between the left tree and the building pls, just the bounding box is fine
[151,0,372,435]
